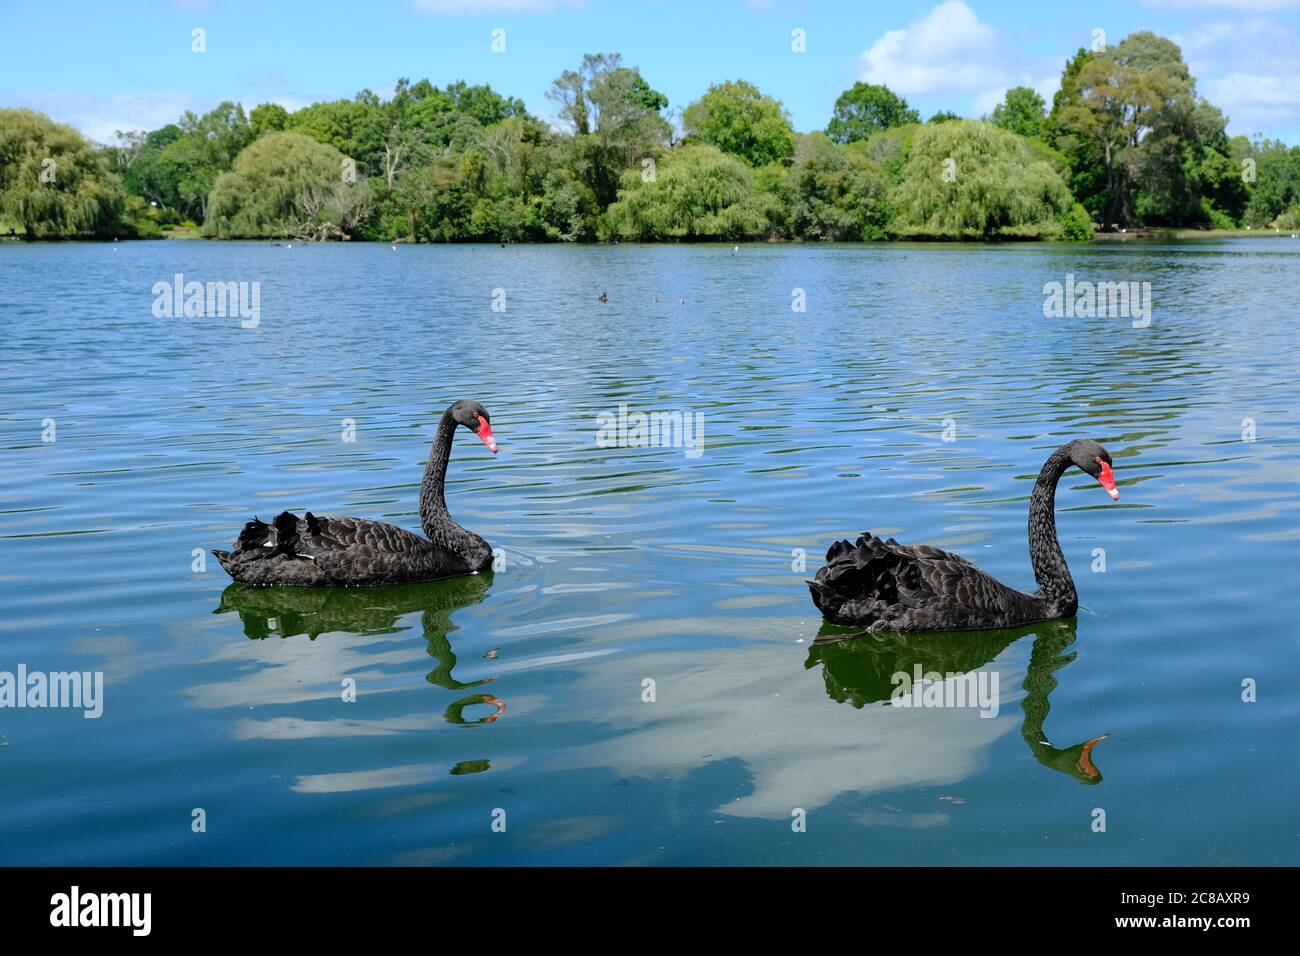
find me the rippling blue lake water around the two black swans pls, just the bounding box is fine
[0,237,1300,865]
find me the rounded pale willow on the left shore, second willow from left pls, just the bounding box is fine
[203,133,369,239]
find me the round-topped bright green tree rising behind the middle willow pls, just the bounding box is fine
[681,79,794,166]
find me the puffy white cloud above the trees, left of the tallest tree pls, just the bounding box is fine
[858,0,1011,96]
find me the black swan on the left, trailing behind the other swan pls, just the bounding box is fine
[213,399,497,588]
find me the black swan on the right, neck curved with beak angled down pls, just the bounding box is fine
[807,438,1119,632]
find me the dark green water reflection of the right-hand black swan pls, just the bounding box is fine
[803,618,1105,784]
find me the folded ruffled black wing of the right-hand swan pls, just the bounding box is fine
[810,533,1018,630]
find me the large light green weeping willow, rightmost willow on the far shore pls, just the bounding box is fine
[891,120,1089,239]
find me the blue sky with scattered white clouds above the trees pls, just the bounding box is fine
[0,0,1300,143]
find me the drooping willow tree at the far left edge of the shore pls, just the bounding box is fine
[0,109,125,239]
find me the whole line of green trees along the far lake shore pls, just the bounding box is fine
[0,33,1300,242]
